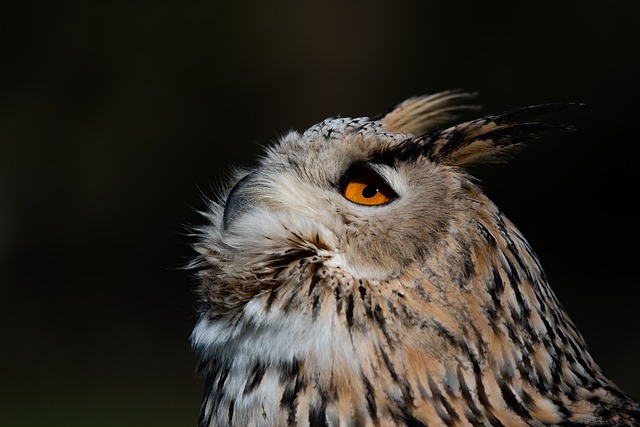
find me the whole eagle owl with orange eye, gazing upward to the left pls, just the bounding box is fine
[191,91,640,427]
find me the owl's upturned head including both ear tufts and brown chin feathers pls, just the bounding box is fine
[194,91,575,315]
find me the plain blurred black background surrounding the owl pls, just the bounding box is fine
[0,0,640,427]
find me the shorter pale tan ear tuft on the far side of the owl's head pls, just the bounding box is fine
[372,90,480,137]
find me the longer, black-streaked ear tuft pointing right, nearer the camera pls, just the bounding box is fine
[416,103,583,166]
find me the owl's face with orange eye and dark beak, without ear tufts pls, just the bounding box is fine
[218,119,461,280]
